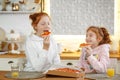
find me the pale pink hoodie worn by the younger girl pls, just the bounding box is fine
[77,44,110,73]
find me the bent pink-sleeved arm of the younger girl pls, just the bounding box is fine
[87,46,109,73]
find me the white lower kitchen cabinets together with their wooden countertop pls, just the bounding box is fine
[0,53,120,71]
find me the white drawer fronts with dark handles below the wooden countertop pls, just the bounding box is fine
[0,58,77,71]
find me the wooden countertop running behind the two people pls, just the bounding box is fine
[0,52,120,60]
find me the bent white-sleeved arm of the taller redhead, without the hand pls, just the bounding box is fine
[25,42,48,71]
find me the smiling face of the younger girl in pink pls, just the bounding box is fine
[86,30,99,46]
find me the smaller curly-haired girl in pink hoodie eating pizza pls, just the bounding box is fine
[77,26,111,73]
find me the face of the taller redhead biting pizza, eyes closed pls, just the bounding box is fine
[36,16,51,35]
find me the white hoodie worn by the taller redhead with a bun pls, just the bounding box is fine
[24,34,60,71]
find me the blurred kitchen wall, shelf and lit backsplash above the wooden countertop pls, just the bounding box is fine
[0,0,120,52]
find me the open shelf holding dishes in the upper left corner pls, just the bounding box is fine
[0,0,45,13]
